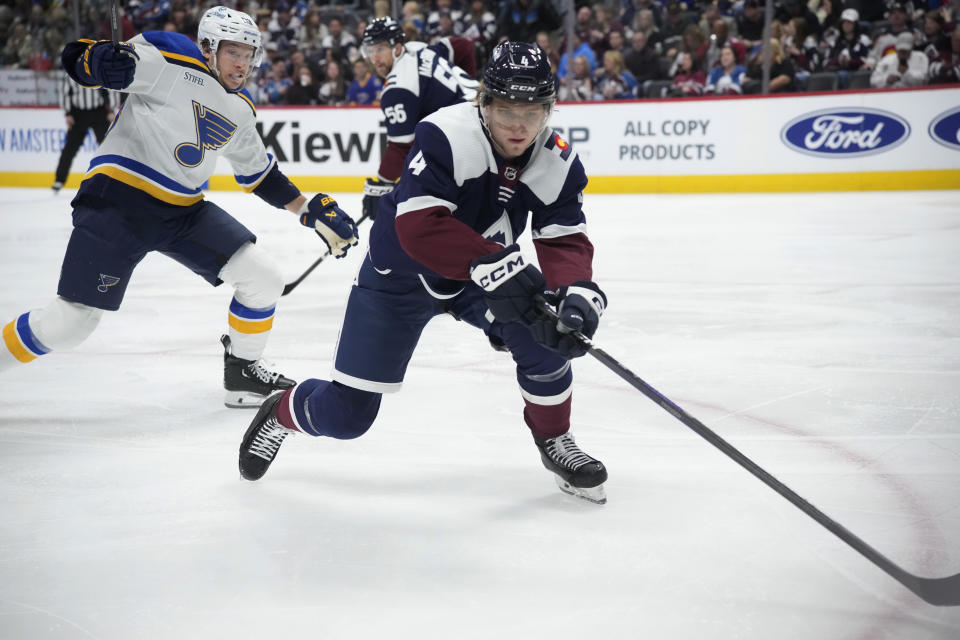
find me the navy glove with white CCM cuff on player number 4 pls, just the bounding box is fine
[470,244,547,324]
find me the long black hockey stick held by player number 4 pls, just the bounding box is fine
[538,299,960,606]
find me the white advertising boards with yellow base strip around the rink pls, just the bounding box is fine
[0,87,960,193]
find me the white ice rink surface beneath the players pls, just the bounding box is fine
[0,189,960,640]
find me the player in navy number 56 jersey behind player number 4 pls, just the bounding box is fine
[361,18,477,220]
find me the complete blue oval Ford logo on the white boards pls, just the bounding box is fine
[780,107,910,158]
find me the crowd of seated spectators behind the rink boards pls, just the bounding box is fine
[0,0,960,105]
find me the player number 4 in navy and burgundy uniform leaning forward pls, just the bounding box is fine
[239,42,607,503]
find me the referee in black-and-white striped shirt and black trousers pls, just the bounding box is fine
[53,74,120,193]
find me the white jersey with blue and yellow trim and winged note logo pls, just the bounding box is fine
[85,31,276,205]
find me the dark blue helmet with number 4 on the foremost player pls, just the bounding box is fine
[482,42,557,104]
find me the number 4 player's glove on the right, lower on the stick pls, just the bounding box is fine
[530,280,607,358]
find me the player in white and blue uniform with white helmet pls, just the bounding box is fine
[0,7,357,407]
